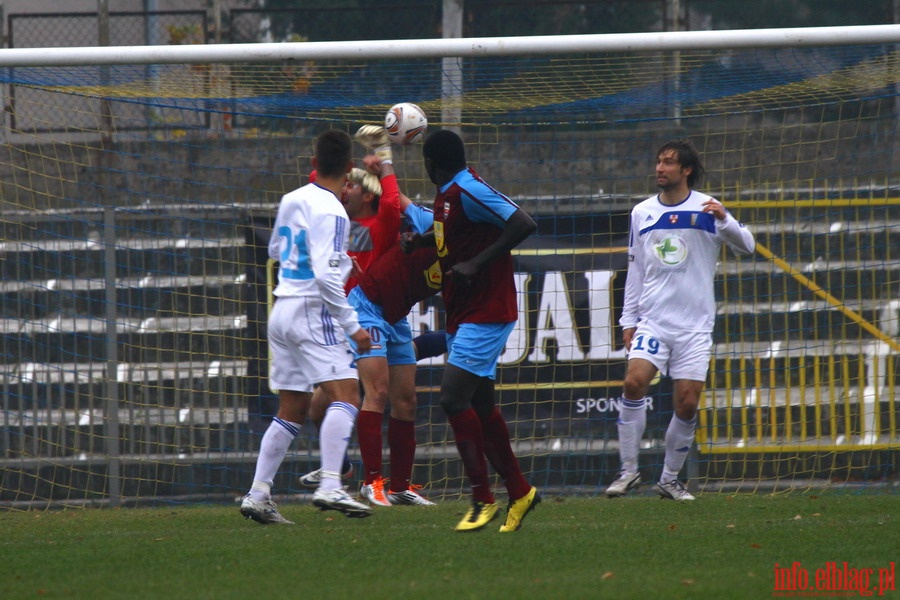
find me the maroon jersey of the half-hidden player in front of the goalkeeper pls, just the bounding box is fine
[359,243,441,324]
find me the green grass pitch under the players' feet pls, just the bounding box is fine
[0,492,900,600]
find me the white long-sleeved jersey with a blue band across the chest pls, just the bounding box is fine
[619,191,756,332]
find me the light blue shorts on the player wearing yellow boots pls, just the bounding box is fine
[447,322,516,379]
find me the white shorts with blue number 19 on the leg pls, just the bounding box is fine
[628,322,712,381]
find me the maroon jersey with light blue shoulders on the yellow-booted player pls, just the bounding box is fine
[434,169,518,334]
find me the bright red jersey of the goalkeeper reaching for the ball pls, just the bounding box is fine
[344,175,400,293]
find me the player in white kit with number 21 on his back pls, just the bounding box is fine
[241,131,372,525]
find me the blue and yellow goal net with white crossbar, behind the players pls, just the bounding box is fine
[0,26,900,507]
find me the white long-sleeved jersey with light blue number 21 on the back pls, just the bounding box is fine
[269,183,360,336]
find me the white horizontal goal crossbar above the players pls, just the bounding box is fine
[0,25,900,67]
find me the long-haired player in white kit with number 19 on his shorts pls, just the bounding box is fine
[606,141,756,500]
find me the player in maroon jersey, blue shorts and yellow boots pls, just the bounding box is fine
[404,130,541,532]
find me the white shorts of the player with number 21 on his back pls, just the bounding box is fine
[267,297,359,392]
